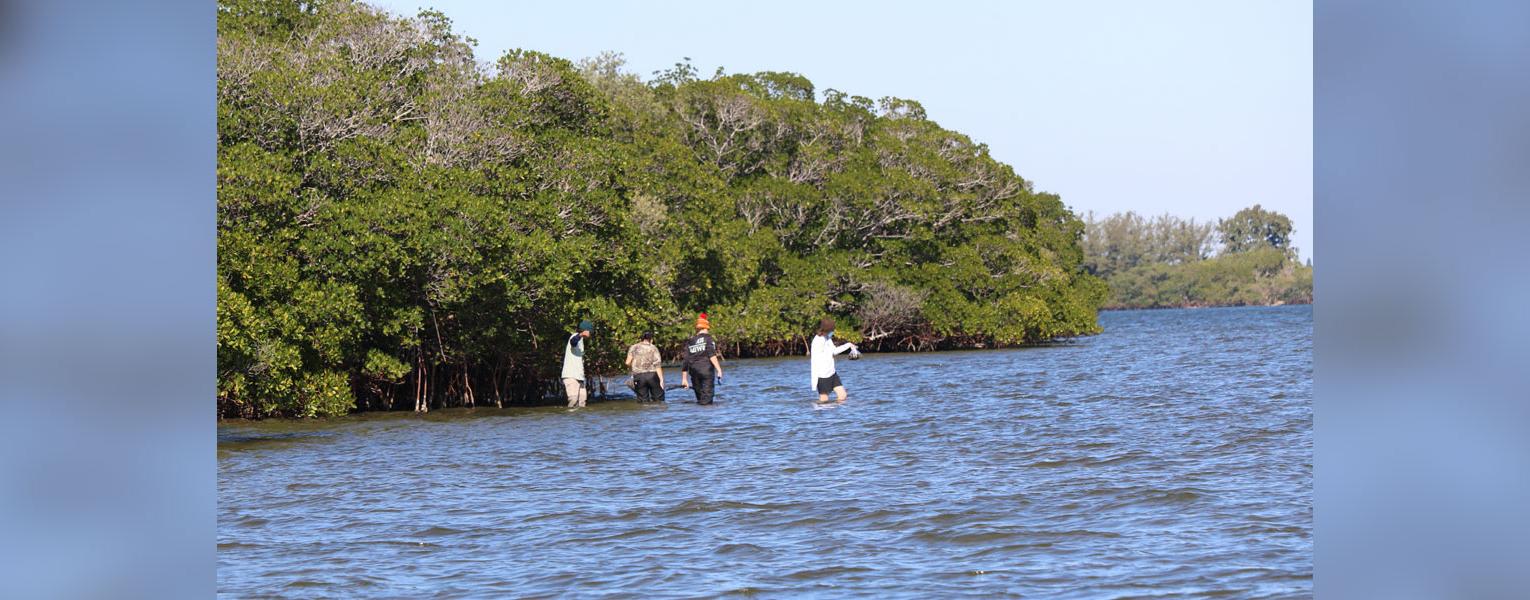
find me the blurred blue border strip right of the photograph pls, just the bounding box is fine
[1313,0,1530,598]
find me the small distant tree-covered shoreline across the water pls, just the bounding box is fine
[1083,205,1313,308]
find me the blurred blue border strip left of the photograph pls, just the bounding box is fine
[0,2,217,598]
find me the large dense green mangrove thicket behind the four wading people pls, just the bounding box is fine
[217,0,1105,416]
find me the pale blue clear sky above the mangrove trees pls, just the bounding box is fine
[372,0,1313,257]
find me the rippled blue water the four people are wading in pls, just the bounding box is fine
[217,306,1313,597]
